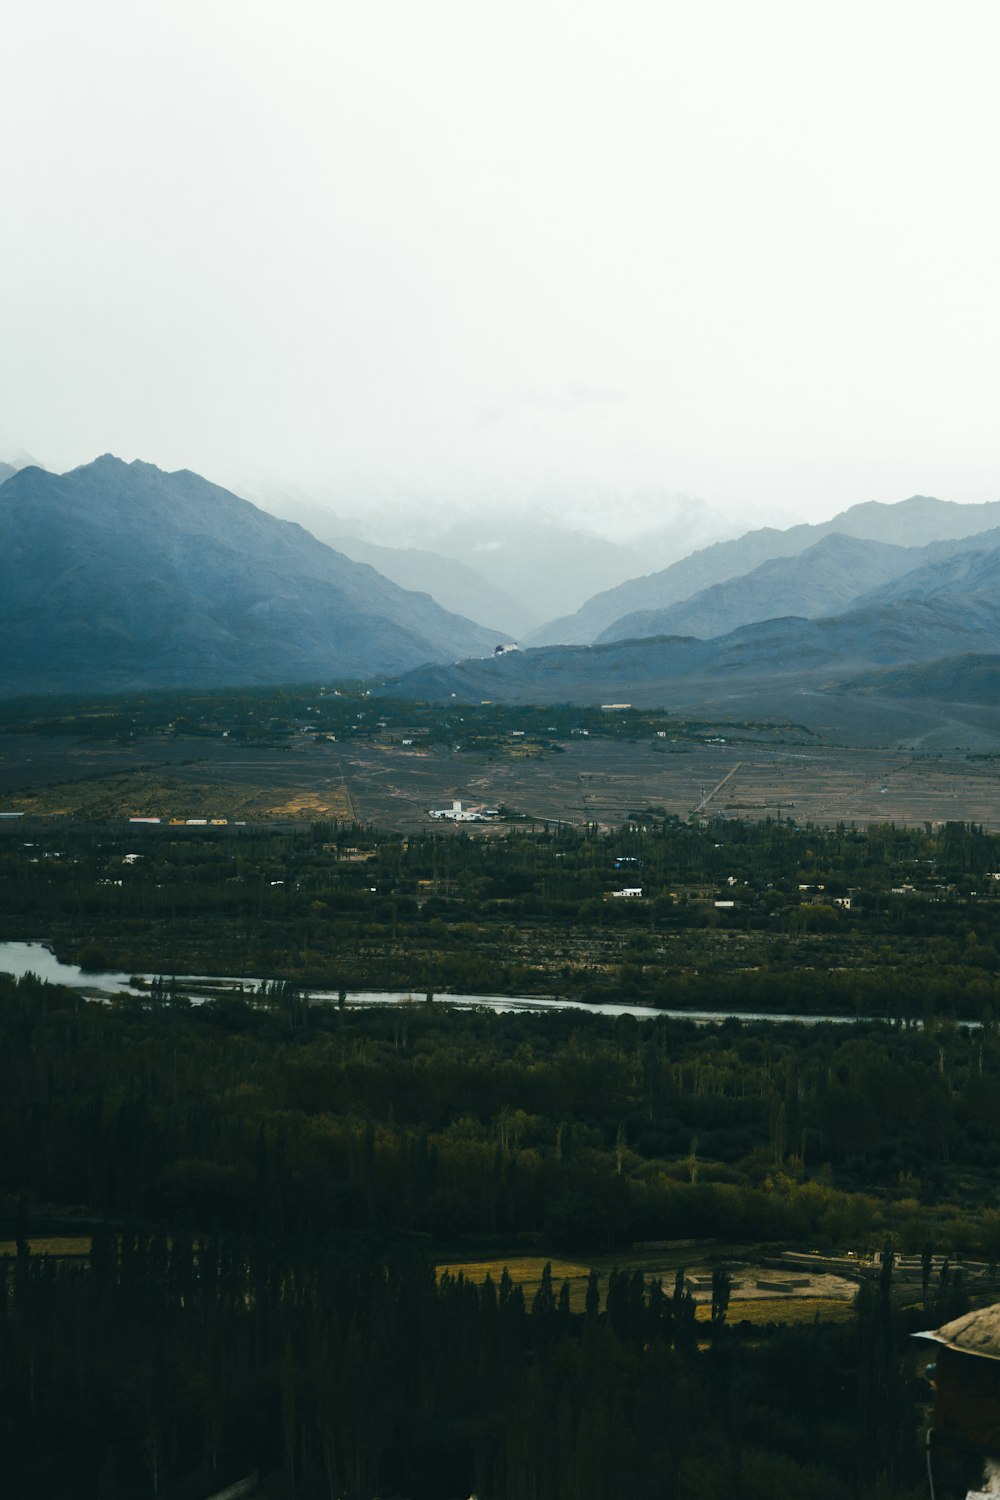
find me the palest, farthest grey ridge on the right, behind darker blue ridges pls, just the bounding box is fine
[526,495,1000,645]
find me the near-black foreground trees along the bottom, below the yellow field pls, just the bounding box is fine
[0,1229,921,1500]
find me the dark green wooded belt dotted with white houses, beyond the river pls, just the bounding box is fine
[0,810,1000,1020]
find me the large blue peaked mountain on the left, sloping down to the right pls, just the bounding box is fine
[0,455,496,693]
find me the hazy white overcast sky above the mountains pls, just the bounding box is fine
[0,0,1000,516]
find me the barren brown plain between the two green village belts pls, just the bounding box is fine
[0,735,1000,833]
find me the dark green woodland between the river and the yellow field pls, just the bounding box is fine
[0,978,1000,1262]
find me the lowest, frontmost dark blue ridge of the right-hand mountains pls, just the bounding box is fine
[387,546,1000,746]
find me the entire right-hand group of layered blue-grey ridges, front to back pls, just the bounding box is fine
[346,497,1000,747]
